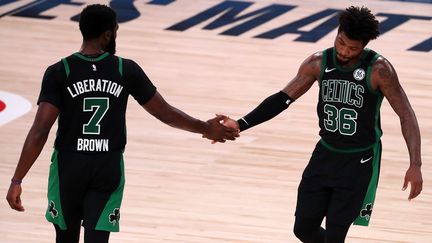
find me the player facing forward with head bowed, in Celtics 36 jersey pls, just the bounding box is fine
[219,7,423,243]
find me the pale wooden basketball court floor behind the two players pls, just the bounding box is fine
[0,0,432,243]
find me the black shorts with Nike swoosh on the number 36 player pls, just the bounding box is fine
[296,142,381,226]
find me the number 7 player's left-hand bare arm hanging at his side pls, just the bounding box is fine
[6,102,59,211]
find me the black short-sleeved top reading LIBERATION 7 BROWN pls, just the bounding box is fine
[38,53,156,153]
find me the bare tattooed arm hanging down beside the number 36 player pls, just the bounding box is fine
[372,57,423,200]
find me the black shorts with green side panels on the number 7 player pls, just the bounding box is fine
[45,150,125,232]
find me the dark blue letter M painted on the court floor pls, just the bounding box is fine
[167,1,295,36]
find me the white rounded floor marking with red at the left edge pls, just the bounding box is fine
[0,91,31,126]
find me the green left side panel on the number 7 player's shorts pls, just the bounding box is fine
[45,150,67,230]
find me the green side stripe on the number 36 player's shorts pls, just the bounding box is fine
[353,142,381,226]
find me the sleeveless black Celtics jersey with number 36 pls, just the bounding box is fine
[317,48,383,151]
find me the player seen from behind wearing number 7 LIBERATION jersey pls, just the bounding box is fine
[7,4,238,243]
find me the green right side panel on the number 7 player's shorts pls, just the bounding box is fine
[95,154,125,232]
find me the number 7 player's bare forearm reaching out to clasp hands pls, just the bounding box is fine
[143,92,239,142]
